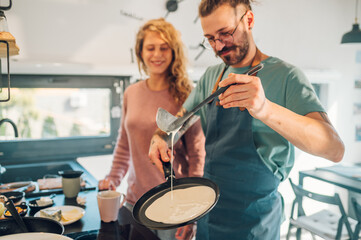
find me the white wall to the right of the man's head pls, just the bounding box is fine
[254,0,361,167]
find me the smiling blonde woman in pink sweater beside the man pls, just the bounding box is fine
[99,19,205,240]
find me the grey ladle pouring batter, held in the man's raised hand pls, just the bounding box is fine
[156,63,263,133]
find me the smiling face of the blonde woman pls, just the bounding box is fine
[142,32,173,75]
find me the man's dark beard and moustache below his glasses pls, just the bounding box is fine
[216,32,249,65]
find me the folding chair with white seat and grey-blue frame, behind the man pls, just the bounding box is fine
[286,179,356,240]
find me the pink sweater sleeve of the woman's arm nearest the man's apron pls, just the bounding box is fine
[184,119,206,177]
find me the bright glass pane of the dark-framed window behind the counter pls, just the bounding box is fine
[0,88,111,140]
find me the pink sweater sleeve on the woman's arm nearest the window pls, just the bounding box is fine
[107,92,130,186]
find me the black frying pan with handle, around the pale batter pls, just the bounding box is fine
[133,162,219,229]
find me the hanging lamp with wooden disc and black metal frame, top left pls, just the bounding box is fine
[0,0,19,102]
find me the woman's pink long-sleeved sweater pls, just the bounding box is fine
[108,80,205,204]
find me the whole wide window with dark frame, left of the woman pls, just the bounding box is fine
[0,75,129,164]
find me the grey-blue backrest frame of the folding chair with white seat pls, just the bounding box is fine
[289,179,352,237]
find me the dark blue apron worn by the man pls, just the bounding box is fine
[196,49,282,240]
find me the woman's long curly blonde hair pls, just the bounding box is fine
[135,18,192,104]
